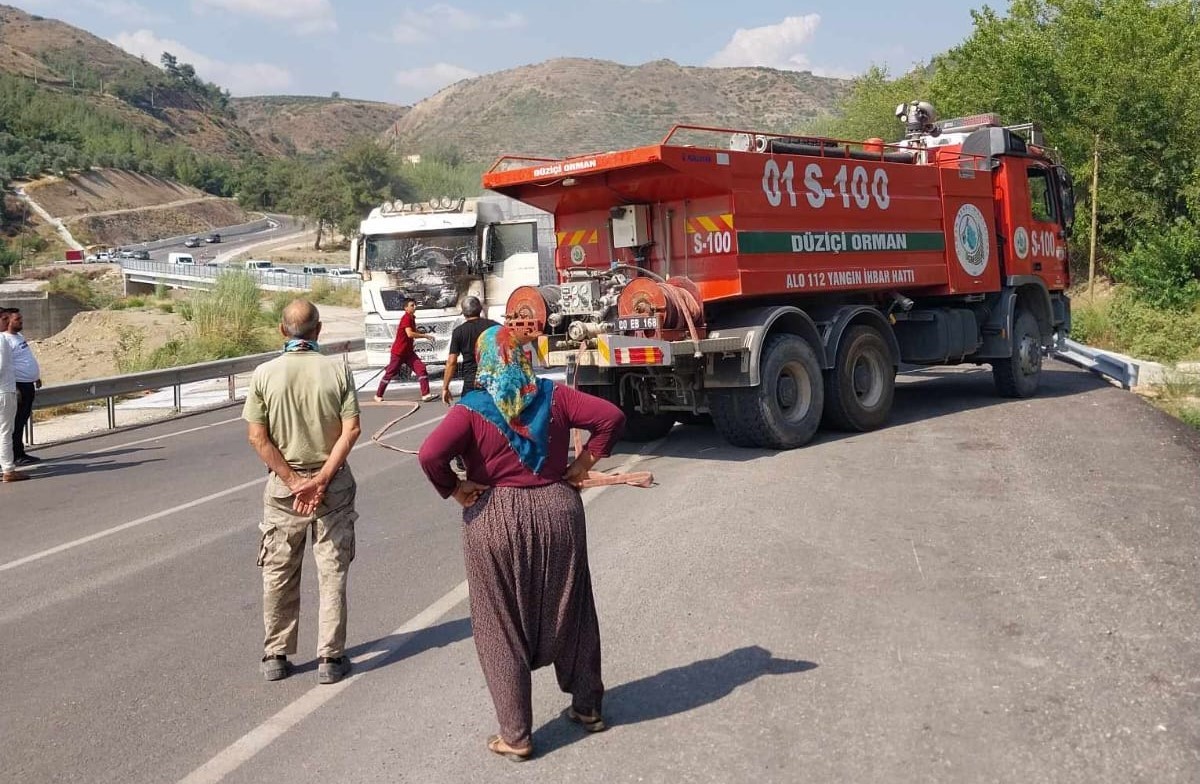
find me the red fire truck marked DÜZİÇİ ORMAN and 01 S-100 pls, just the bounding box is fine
[484,102,1074,449]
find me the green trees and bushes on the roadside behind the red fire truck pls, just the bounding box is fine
[805,0,1200,423]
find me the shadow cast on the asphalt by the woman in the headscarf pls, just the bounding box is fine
[533,645,817,756]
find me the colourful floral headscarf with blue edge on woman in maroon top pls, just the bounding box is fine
[461,327,554,473]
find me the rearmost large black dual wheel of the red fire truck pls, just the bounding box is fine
[709,334,824,449]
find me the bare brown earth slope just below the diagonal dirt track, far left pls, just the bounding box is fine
[70,198,254,246]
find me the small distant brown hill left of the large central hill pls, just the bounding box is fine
[230,95,408,155]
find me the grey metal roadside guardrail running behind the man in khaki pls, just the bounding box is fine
[26,337,366,443]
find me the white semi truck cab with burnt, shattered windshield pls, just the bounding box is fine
[350,193,557,366]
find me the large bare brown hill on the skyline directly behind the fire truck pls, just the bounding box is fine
[383,59,850,161]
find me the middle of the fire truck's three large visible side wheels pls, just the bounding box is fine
[824,327,896,432]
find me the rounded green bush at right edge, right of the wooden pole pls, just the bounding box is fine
[1111,219,1200,310]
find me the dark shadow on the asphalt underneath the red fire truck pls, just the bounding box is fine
[602,361,1110,471]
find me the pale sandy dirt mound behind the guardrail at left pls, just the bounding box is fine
[30,310,191,384]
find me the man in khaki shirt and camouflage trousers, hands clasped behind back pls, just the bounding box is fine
[242,299,361,683]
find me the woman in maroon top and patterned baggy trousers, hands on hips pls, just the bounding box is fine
[419,327,624,761]
